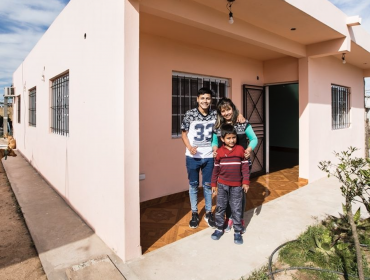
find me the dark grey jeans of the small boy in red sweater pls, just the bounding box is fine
[215,183,244,232]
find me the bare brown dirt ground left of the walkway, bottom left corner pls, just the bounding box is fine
[0,162,47,280]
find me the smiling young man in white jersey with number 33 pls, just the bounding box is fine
[181,88,217,228]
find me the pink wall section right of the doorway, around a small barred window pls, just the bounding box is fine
[300,57,365,181]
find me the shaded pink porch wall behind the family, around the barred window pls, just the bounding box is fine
[140,33,263,201]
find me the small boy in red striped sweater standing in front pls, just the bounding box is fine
[211,124,249,244]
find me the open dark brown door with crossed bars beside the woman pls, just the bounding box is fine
[243,85,266,176]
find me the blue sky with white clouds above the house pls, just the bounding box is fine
[0,0,370,100]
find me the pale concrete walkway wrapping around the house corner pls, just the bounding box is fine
[3,148,352,280]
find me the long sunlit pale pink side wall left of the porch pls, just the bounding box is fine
[13,0,141,260]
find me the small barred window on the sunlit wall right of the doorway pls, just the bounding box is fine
[331,85,351,129]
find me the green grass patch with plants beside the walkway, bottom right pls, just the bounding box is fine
[241,215,370,280]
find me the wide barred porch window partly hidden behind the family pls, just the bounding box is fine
[172,72,229,138]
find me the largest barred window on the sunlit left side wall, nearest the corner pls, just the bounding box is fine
[50,73,69,136]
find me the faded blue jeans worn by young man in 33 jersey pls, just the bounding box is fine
[186,156,213,212]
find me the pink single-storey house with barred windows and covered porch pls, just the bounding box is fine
[13,0,370,260]
